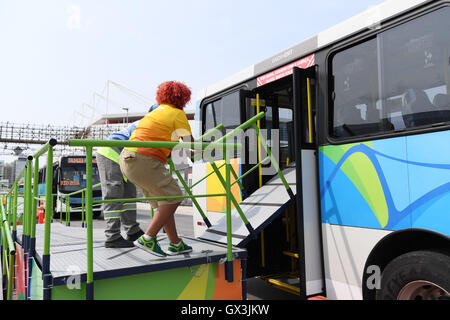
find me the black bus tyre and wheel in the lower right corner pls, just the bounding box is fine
[376,251,450,300]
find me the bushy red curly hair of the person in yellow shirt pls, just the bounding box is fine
[156,81,191,109]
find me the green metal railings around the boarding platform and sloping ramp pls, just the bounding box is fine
[2,112,293,299]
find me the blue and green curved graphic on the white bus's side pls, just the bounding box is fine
[319,131,450,235]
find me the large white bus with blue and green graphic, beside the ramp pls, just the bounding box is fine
[192,0,450,299]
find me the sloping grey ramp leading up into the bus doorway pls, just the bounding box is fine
[199,166,296,247]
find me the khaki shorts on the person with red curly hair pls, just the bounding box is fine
[119,149,183,209]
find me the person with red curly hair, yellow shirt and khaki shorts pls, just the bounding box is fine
[119,81,194,257]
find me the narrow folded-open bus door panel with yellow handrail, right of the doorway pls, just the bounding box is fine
[292,66,325,297]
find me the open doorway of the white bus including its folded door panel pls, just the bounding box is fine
[242,67,324,297]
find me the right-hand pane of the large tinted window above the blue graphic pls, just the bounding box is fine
[381,7,450,130]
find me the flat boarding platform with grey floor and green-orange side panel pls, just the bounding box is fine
[17,223,247,299]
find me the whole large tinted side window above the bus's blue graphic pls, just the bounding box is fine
[331,7,450,138]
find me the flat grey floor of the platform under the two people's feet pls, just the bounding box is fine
[17,223,246,285]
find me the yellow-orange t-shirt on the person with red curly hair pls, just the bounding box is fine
[127,104,192,163]
